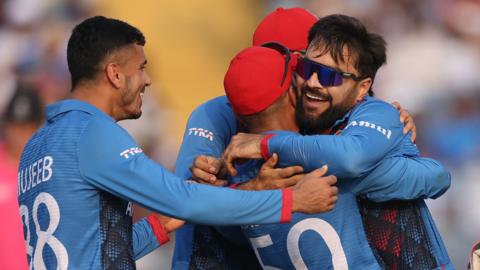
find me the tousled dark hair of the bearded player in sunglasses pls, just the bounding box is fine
[308,14,387,96]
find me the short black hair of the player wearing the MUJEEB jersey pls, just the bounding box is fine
[67,16,145,90]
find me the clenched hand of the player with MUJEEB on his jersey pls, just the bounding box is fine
[292,165,338,214]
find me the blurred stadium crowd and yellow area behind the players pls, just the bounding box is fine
[0,0,480,269]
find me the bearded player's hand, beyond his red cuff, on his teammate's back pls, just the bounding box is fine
[223,133,265,176]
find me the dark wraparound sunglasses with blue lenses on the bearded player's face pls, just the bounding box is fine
[295,58,363,87]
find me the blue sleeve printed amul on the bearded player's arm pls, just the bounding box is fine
[268,100,405,179]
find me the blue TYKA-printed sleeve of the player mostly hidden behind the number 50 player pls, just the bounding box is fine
[175,96,237,179]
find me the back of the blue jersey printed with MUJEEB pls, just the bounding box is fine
[18,102,135,269]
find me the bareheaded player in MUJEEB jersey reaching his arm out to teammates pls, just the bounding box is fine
[18,16,336,269]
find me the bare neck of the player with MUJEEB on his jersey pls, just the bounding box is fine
[72,84,121,121]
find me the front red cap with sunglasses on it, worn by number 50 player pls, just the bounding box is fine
[223,46,296,115]
